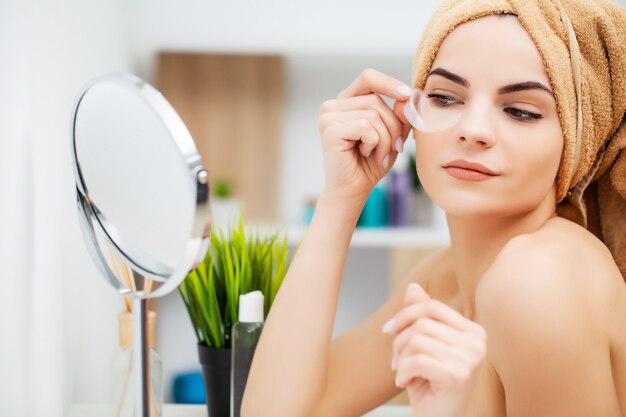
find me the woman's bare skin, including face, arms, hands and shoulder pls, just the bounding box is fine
[242,16,626,417]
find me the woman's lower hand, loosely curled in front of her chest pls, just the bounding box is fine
[383,284,487,417]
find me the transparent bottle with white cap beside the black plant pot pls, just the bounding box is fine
[230,291,264,417]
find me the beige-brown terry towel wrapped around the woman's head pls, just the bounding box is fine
[413,0,626,279]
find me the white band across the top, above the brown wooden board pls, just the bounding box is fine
[129,0,438,80]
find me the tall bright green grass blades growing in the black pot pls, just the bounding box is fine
[178,214,289,348]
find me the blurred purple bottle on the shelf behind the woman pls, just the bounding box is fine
[387,153,412,227]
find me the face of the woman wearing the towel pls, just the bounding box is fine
[414,16,563,217]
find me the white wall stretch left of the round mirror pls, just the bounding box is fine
[0,0,130,417]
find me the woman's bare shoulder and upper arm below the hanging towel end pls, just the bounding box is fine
[476,218,626,416]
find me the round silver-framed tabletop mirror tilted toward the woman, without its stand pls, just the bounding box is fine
[72,74,210,299]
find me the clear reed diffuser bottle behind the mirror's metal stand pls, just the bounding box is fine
[109,311,163,417]
